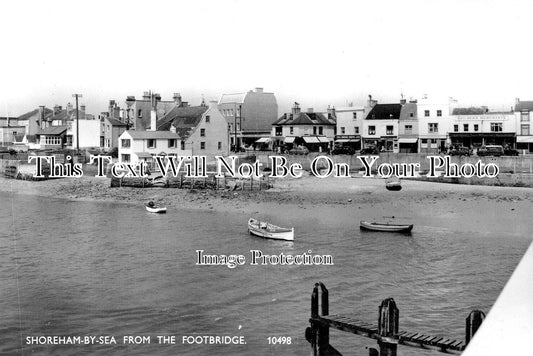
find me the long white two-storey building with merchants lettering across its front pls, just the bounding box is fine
[448,107,516,148]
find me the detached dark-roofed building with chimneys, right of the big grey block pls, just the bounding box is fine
[271,103,337,152]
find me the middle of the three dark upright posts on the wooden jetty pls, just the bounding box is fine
[378,298,400,356]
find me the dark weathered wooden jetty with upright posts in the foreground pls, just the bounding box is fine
[305,283,485,356]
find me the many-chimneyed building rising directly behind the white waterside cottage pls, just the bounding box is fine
[125,91,182,131]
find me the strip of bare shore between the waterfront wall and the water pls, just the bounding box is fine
[0,175,533,236]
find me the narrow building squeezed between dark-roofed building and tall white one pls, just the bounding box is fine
[398,98,418,153]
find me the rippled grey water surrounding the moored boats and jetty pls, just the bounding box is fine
[0,194,530,355]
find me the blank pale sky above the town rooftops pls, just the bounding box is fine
[0,0,533,116]
